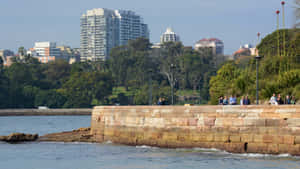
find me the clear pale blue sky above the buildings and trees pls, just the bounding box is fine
[0,0,294,54]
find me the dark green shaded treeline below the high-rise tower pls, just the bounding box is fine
[0,38,216,108]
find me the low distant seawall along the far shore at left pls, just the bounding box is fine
[0,109,92,116]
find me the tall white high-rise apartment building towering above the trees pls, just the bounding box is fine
[80,8,149,61]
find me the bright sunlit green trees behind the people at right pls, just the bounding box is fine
[210,29,300,104]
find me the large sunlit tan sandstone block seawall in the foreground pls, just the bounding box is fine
[91,106,300,155]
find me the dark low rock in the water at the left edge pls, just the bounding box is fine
[0,133,39,143]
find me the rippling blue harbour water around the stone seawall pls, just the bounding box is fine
[0,116,300,169]
